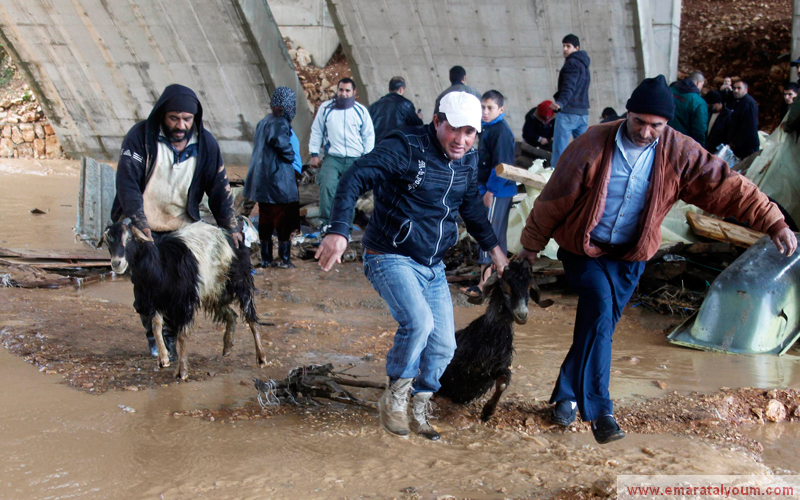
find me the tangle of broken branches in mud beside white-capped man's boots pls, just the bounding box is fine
[253,363,386,408]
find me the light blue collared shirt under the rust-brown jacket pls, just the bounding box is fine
[591,123,658,245]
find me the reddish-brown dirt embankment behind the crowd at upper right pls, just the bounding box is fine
[678,0,792,132]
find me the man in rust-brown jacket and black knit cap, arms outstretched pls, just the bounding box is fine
[520,75,797,444]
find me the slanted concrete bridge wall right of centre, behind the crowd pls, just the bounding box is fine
[328,0,680,135]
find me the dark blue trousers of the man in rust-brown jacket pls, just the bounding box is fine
[550,249,645,422]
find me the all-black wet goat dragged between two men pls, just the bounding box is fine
[437,260,553,421]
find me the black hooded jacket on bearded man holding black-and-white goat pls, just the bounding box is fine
[111,84,237,232]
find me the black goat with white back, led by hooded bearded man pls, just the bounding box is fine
[101,222,267,380]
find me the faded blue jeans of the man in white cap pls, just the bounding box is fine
[364,252,456,393]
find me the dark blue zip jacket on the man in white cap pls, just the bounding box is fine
[328,123,497,266]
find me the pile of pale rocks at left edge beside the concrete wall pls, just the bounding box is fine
[0,88,64,158]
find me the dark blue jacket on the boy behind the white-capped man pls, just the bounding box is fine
[478,114,517,198]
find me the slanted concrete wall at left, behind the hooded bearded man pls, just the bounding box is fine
[0,0,311,164]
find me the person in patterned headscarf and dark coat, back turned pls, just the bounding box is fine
[242,87,303,269]
